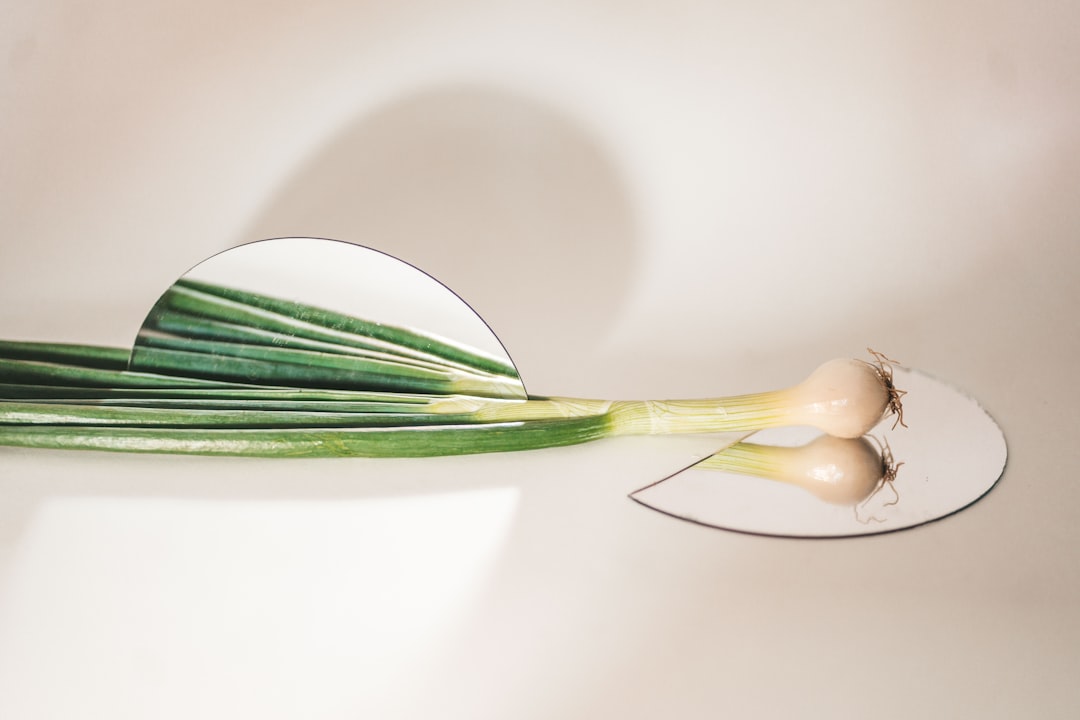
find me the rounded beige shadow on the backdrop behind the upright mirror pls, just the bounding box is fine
[245,86,638,385]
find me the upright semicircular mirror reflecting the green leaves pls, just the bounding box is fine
[130,237,526,398]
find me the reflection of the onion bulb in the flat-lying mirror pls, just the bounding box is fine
[697,435,895,505]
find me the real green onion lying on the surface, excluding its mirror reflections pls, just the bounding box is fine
[0,354,890,457]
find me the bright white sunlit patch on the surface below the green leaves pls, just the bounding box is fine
[0,488,517,718]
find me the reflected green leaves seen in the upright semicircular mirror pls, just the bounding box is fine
[137,280,525,398]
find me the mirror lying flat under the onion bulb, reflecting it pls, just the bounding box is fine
[631,369,1007,538]
